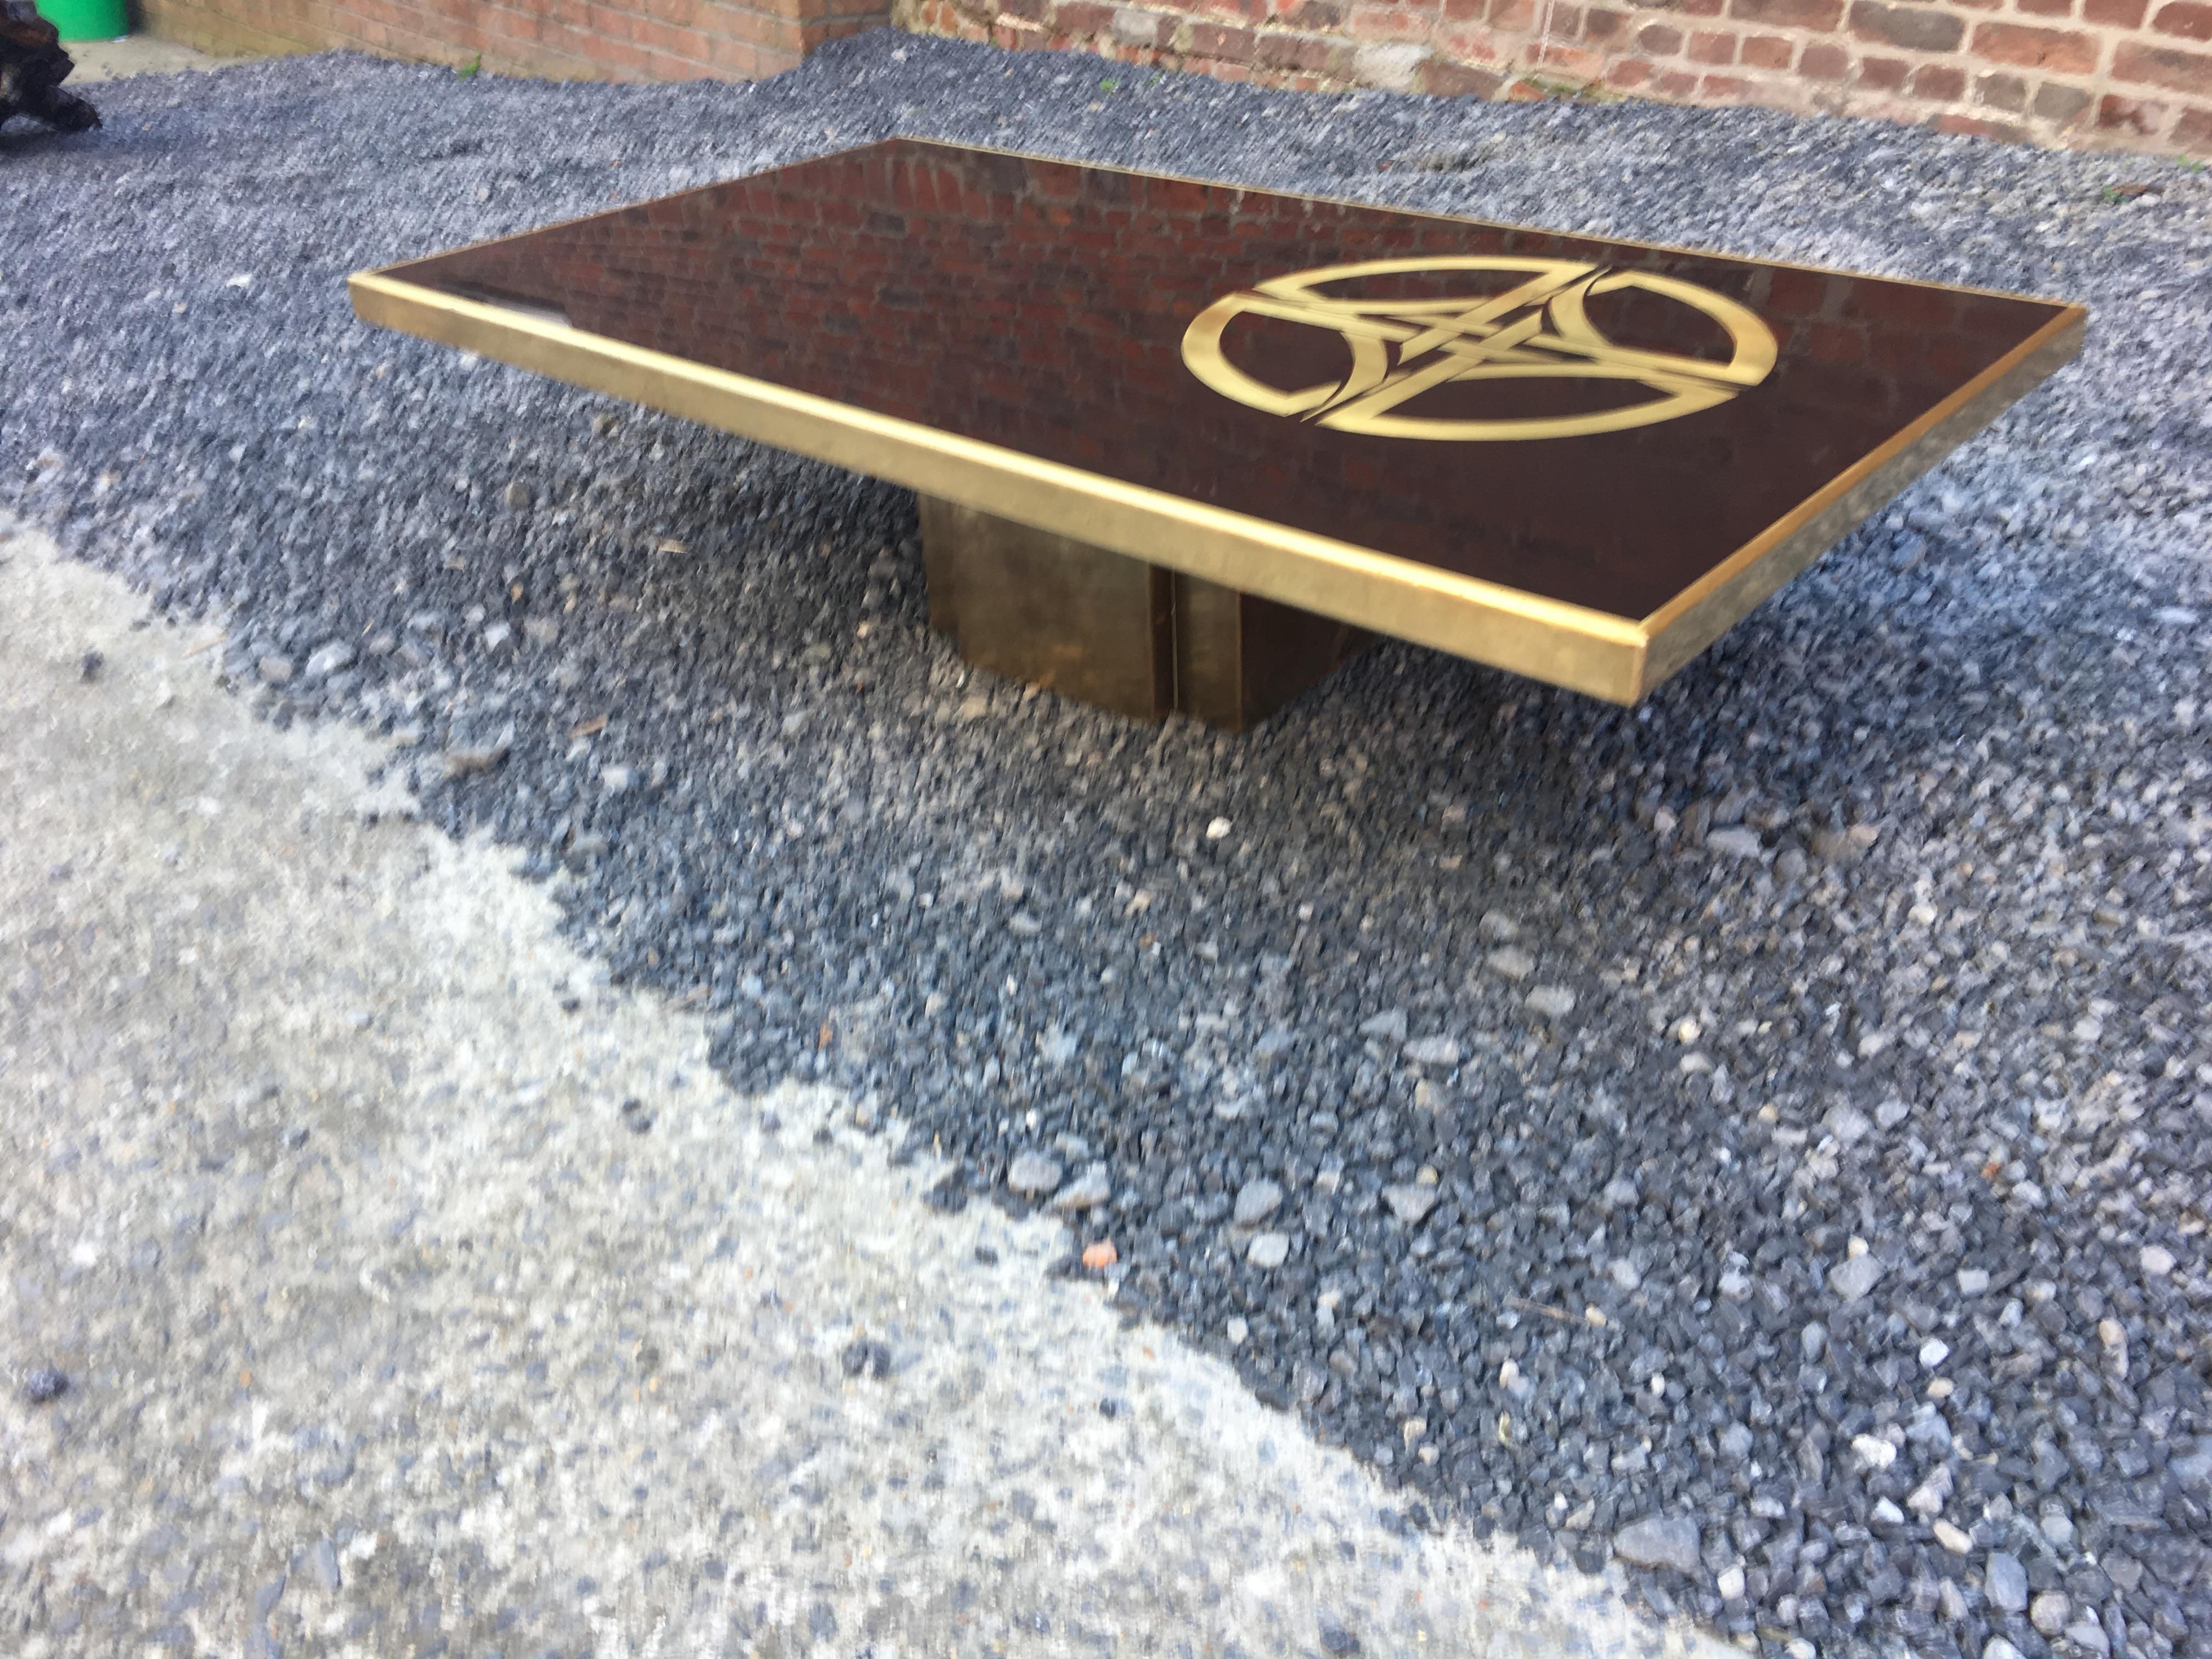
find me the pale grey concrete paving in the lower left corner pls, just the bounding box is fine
[0,524,1703,1659]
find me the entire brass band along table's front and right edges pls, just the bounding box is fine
[347,272,2088,703]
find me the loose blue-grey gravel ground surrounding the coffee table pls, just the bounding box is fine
[0,33,2212,1659]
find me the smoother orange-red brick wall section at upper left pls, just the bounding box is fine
[139,0,889,80]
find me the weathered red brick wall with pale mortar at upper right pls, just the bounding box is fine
[896,0,2212,155]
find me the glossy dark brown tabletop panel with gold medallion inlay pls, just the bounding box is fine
[390,139,2066,617]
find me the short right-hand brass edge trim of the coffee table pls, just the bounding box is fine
[1637,305,2088,697]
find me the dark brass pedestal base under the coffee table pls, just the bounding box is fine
[920,495,1374,732]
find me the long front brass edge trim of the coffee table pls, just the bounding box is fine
[347,272,1646,703]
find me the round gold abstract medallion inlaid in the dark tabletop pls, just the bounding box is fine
[1183,257,1776,442]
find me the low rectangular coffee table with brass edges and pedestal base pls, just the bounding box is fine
[352,139,2086,730]
